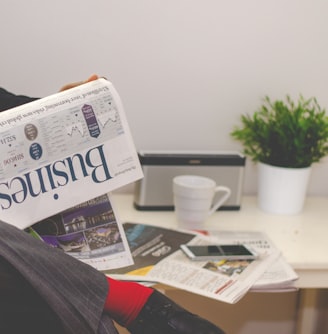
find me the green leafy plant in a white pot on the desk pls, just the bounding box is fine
[231,95,328,214]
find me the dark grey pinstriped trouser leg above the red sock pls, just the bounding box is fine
[0,221,117,334]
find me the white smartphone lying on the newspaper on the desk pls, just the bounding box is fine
[180,244,258,261]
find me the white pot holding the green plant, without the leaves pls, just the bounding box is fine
[258,163,311,215]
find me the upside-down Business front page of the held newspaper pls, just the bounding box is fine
[0,79,142,228]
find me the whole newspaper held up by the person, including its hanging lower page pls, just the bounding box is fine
[0,79,143,270]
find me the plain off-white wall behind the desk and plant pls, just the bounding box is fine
[0,0,328,195]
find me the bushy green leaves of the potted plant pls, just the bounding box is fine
[231,95,328,168]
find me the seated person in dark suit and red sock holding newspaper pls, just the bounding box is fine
[0,75,224,334]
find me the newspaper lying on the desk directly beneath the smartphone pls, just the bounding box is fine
[106,223,296,303]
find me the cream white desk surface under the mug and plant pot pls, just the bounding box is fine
[113,193,328,288]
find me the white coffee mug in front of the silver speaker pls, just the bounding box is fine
[173,175,231,229]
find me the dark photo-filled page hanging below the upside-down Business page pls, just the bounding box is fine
[28,194,133,270]
